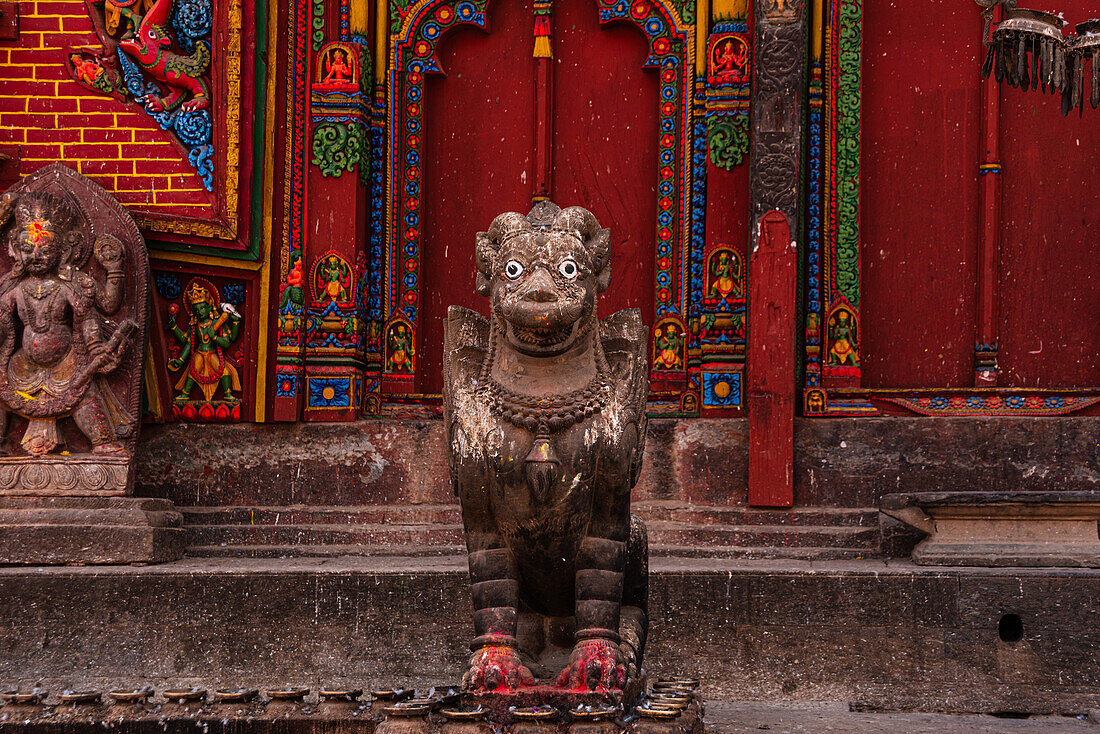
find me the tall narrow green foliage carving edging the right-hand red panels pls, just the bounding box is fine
[836,0,864,309]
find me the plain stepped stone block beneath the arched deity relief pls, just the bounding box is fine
[0,496,185,566]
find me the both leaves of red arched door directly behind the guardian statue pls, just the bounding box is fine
[417,0,658,394]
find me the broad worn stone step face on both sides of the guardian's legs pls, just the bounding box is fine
[0,556,1100,714]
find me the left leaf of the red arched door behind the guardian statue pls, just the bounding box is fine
[418,0,535,394]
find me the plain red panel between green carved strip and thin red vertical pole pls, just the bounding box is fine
[860,2,981,387]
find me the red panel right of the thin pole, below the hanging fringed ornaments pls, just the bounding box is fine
[998,0,1100,387]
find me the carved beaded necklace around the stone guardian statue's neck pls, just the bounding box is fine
[479,325,611,436]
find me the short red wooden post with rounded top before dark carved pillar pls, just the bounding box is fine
[746,210,799,507]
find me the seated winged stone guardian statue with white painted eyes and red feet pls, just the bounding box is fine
[443,202,649,692]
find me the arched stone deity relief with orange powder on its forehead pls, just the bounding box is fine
[0,164,149,494]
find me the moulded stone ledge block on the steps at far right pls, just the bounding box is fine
[882,492,1100,568]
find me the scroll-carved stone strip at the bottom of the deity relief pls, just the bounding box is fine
[0,452,130,497]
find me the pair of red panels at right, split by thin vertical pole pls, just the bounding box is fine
[860,0,1100,388]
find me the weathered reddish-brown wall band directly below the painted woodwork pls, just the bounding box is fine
[138,417,1100,507]
